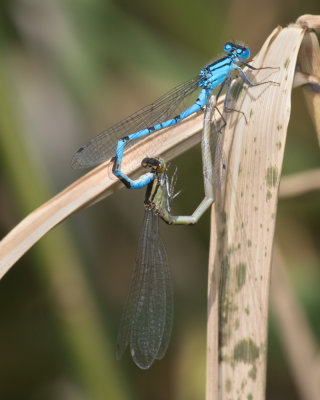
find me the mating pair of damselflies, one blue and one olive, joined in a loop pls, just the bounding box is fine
[72,42,275,368]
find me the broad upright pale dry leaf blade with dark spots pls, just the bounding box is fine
[206,21,318,399]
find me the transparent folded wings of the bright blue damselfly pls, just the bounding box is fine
[71,77,199,168]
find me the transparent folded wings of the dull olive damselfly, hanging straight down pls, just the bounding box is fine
[117,210,173,369]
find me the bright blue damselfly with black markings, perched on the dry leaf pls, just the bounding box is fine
[72,42,275,189]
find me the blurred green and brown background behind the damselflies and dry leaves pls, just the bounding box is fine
[0,0,320,400]
